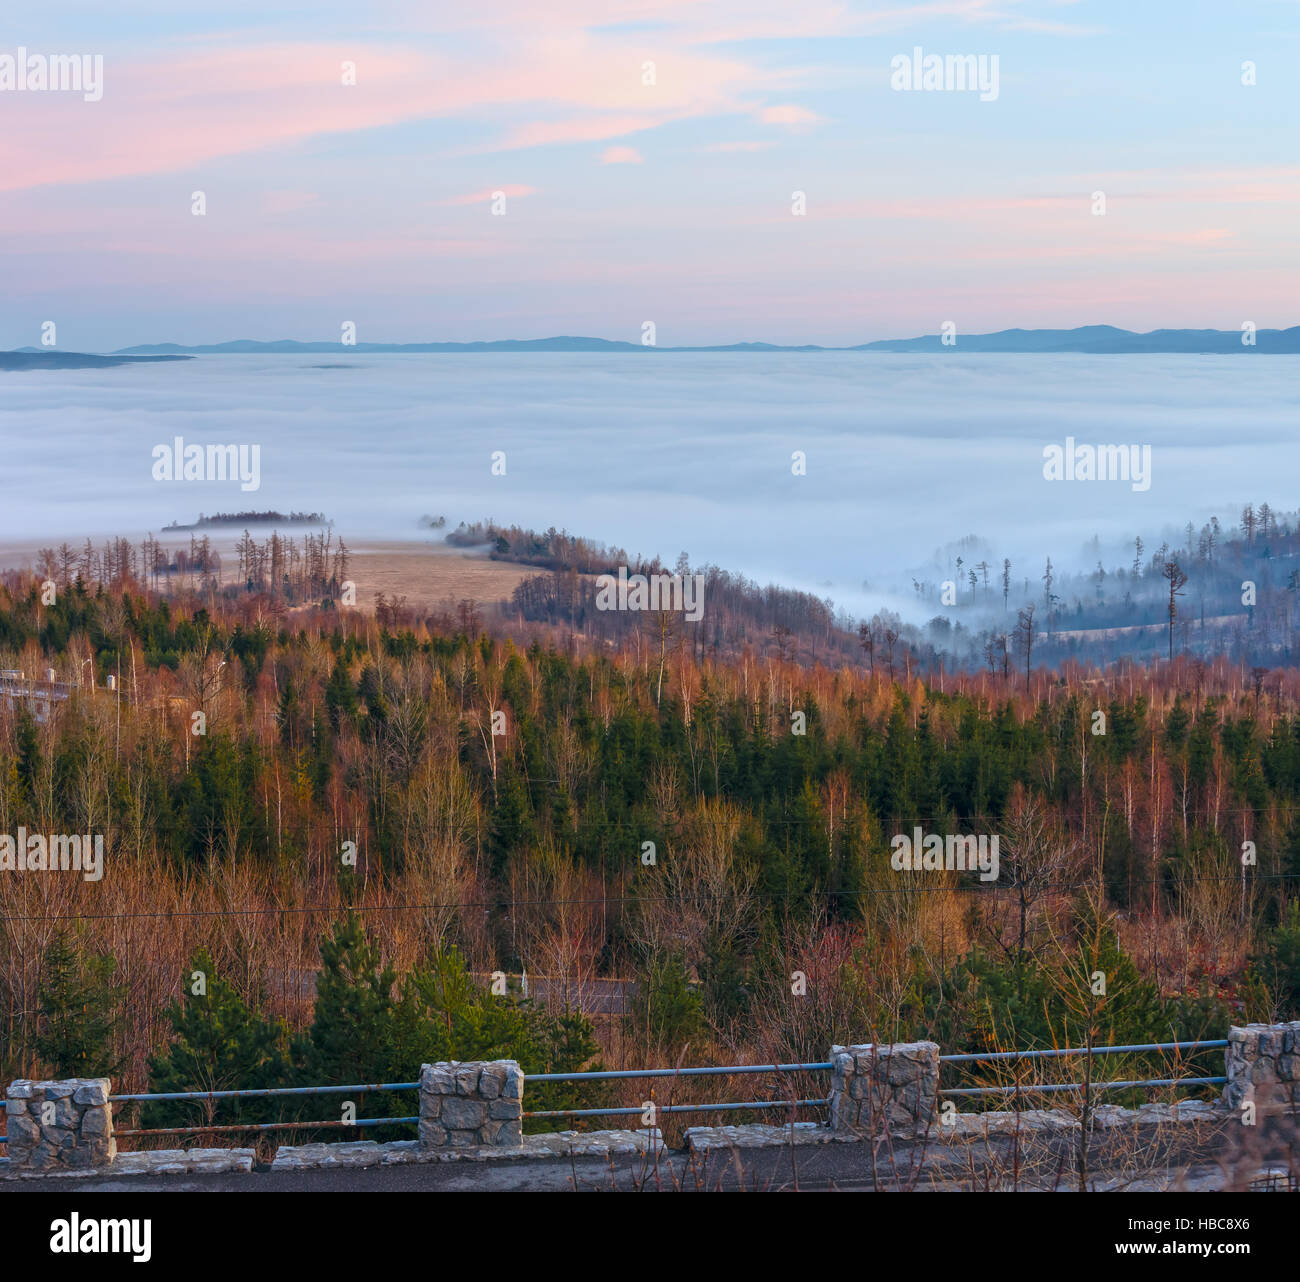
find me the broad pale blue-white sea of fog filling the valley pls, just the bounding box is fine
[0,348,1300,614]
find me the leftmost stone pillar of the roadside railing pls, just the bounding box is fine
[4,1078,117,1171]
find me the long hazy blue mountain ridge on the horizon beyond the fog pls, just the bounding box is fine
[113,325,1300,356]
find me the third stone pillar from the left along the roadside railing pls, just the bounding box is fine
[831,1041,939,1135]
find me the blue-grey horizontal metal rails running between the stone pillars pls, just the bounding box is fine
[0,1038,1227,1144]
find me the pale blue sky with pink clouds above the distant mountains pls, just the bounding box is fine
[0,0,1300,351]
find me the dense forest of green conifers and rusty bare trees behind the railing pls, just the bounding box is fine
[0,548,1300,1149]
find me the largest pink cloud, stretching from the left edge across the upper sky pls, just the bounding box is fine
[0,33,763,191]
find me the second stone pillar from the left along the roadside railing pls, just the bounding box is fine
[420,1060,524,1148]
